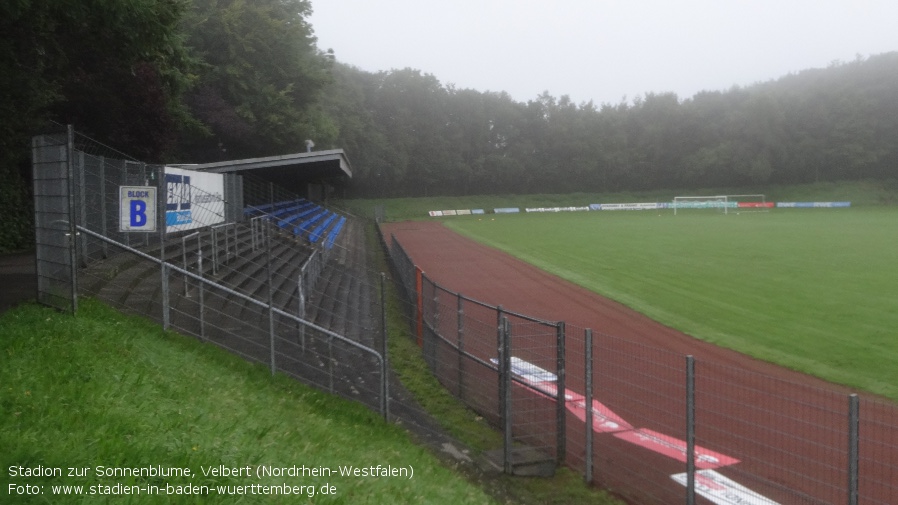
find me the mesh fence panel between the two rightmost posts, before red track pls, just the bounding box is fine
[696,361,848,504]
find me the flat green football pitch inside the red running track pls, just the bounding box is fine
[446,207,898,400]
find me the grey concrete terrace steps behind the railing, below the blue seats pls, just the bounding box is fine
[74,218,380,373]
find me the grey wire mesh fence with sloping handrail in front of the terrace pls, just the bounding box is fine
[32,127,389,416]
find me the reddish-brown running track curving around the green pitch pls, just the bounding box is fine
[382,222,898,505]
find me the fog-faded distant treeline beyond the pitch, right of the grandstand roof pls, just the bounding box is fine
[325,53,898,196]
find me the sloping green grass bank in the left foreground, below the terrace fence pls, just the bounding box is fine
[0,300,494,504]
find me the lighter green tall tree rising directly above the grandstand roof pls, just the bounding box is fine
[184,0,337,161]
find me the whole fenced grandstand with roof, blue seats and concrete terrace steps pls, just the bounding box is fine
[33,129,387,415]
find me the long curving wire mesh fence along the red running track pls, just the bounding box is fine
[383,229,898,505]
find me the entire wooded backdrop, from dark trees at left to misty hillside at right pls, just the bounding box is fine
[0,0,898,251]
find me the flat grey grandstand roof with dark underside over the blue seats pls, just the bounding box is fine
[175,149,352,193]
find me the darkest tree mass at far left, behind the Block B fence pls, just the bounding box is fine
[0,0,190,249]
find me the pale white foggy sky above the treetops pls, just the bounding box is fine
[309,0,898,105]
